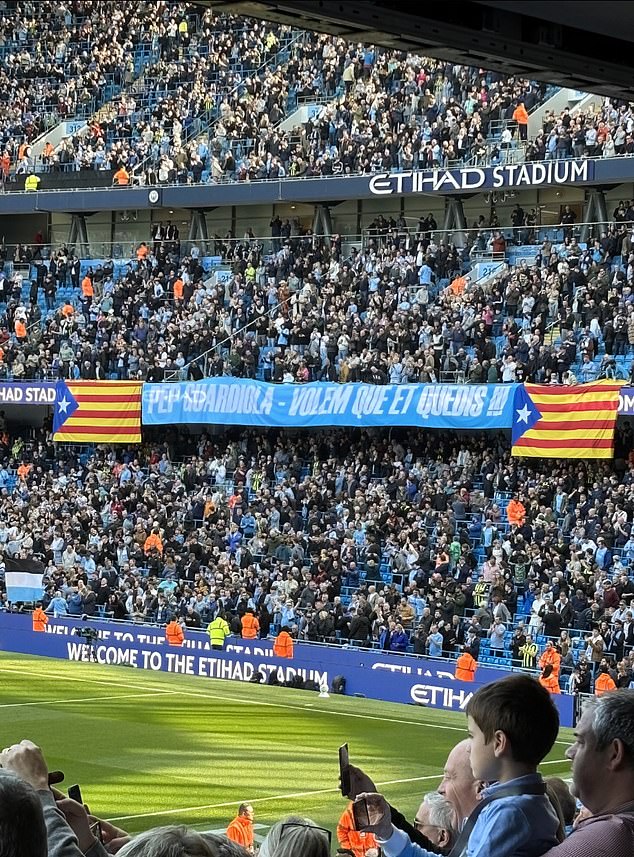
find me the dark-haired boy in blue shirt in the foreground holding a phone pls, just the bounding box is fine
[357,675,559,857]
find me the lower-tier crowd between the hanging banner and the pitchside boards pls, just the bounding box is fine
[0,418,634,691]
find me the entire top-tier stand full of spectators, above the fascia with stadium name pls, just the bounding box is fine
[5,2,552,184]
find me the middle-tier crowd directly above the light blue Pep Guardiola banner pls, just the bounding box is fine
[0,200,634,384]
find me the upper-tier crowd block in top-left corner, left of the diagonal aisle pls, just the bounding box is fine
[0,0,198,179]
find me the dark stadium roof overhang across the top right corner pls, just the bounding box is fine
[198,0,634,101]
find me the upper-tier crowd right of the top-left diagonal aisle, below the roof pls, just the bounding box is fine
[43,4,547,184]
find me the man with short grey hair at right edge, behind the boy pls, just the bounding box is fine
[544,690,634,857]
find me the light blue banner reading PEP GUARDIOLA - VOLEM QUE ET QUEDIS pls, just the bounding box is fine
[143,378,517,430]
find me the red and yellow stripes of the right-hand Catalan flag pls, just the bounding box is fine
[512,381,624,458]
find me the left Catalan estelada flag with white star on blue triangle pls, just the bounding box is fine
[53,381,143,443]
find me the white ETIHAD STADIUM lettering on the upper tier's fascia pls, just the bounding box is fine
[368,159,595,196]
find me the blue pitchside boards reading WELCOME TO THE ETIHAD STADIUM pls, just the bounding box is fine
[0,613,574,726]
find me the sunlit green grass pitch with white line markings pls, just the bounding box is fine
[0,653,570,836]
